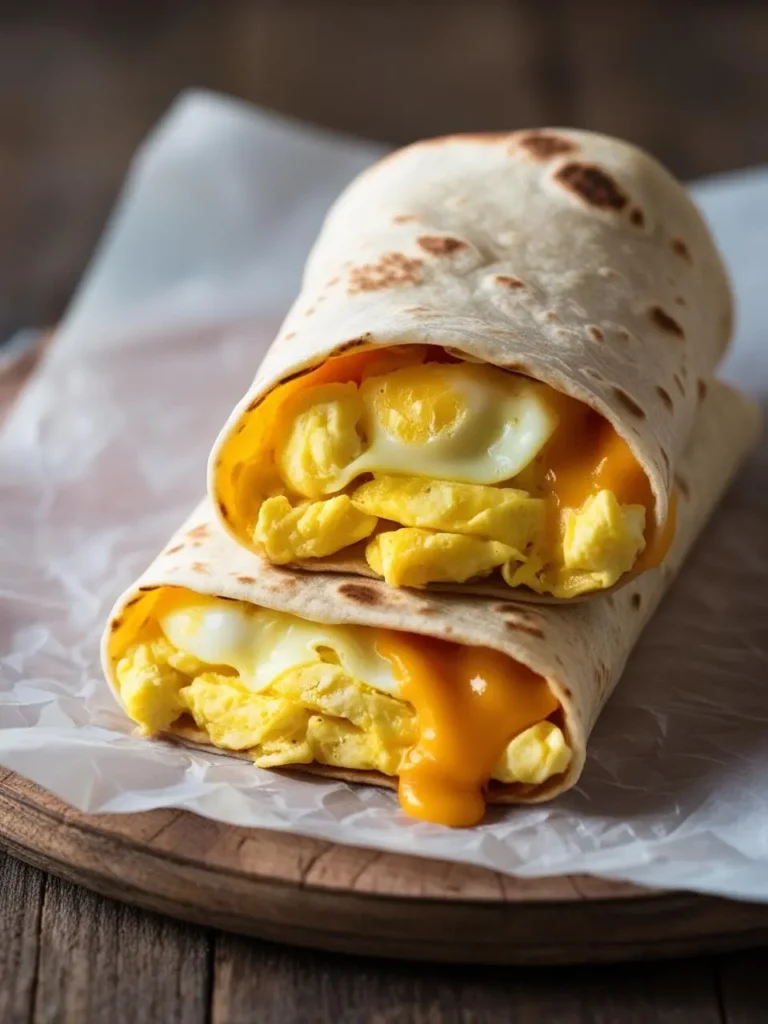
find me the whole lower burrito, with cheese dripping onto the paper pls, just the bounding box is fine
[102,383,758,825]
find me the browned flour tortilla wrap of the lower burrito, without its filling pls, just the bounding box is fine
[102,382,759,802]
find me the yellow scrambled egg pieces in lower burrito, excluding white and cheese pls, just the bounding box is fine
[116,622,571,784]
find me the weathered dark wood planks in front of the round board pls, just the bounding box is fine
[0,839,768,1024]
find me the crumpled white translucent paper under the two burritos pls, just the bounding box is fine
[0,94,768,899]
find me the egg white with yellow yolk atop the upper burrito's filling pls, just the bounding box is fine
[276,362,557,499]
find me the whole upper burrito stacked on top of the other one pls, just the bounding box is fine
[209,129,732,601]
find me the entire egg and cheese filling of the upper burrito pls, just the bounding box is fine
[227,345,674,598]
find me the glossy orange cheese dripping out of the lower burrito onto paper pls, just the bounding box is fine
[376,630,559,826]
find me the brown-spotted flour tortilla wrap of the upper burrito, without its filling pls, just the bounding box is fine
[209,129,733,597]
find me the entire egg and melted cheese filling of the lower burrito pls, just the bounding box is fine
[113,587,571,826]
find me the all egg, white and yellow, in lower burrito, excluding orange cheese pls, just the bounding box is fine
[116,592,571,784]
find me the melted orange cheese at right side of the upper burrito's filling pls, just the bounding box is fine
[537,394,676,572]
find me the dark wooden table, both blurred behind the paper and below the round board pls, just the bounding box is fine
[0,0,768,1024]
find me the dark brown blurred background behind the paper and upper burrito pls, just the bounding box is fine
[0,0,768,338]
